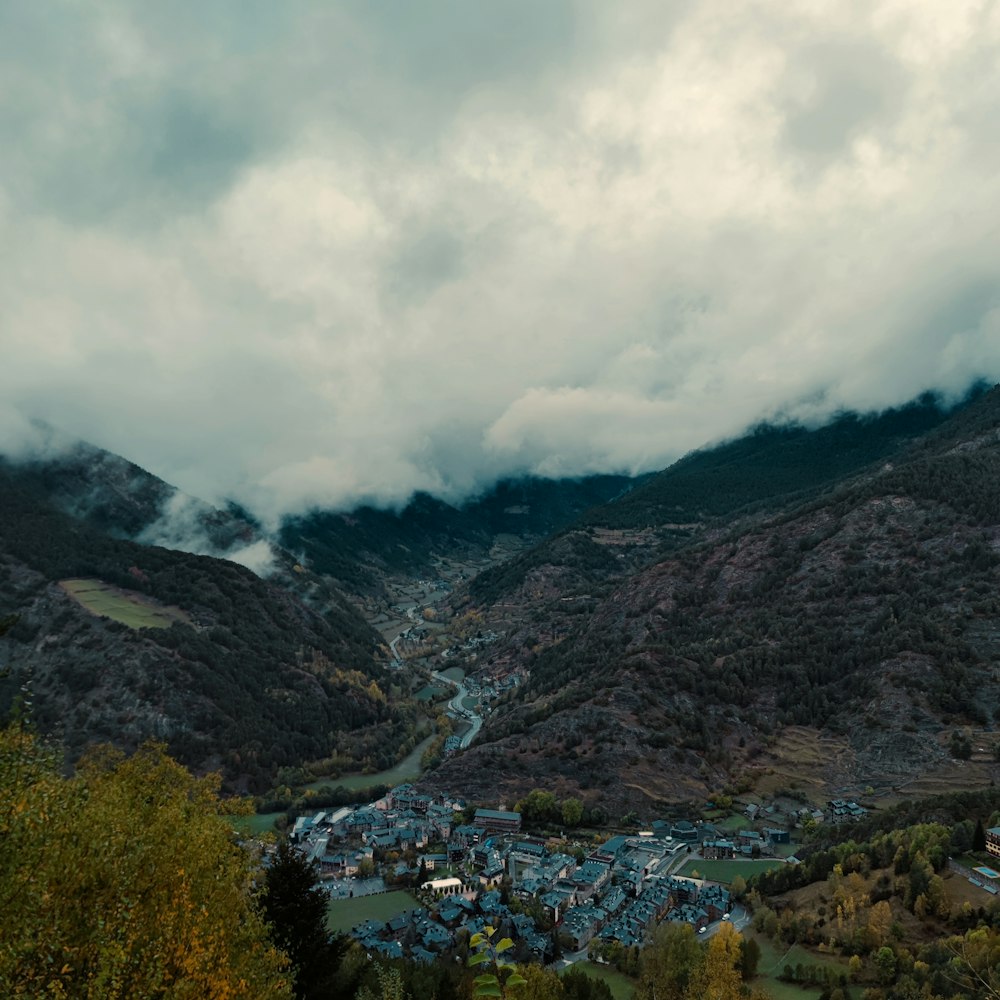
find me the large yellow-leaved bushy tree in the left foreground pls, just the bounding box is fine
[0,725,292,1000]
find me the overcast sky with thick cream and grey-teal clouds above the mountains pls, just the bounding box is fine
[0,0,1000,520]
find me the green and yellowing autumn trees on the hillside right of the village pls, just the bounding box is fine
[750,812,1000,1000]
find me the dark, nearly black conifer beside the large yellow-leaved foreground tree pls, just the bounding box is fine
[261,840,347,1000]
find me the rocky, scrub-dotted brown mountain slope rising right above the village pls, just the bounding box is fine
[434,389,1000,807]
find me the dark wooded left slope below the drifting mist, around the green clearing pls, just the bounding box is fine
[0,465,412,788]
